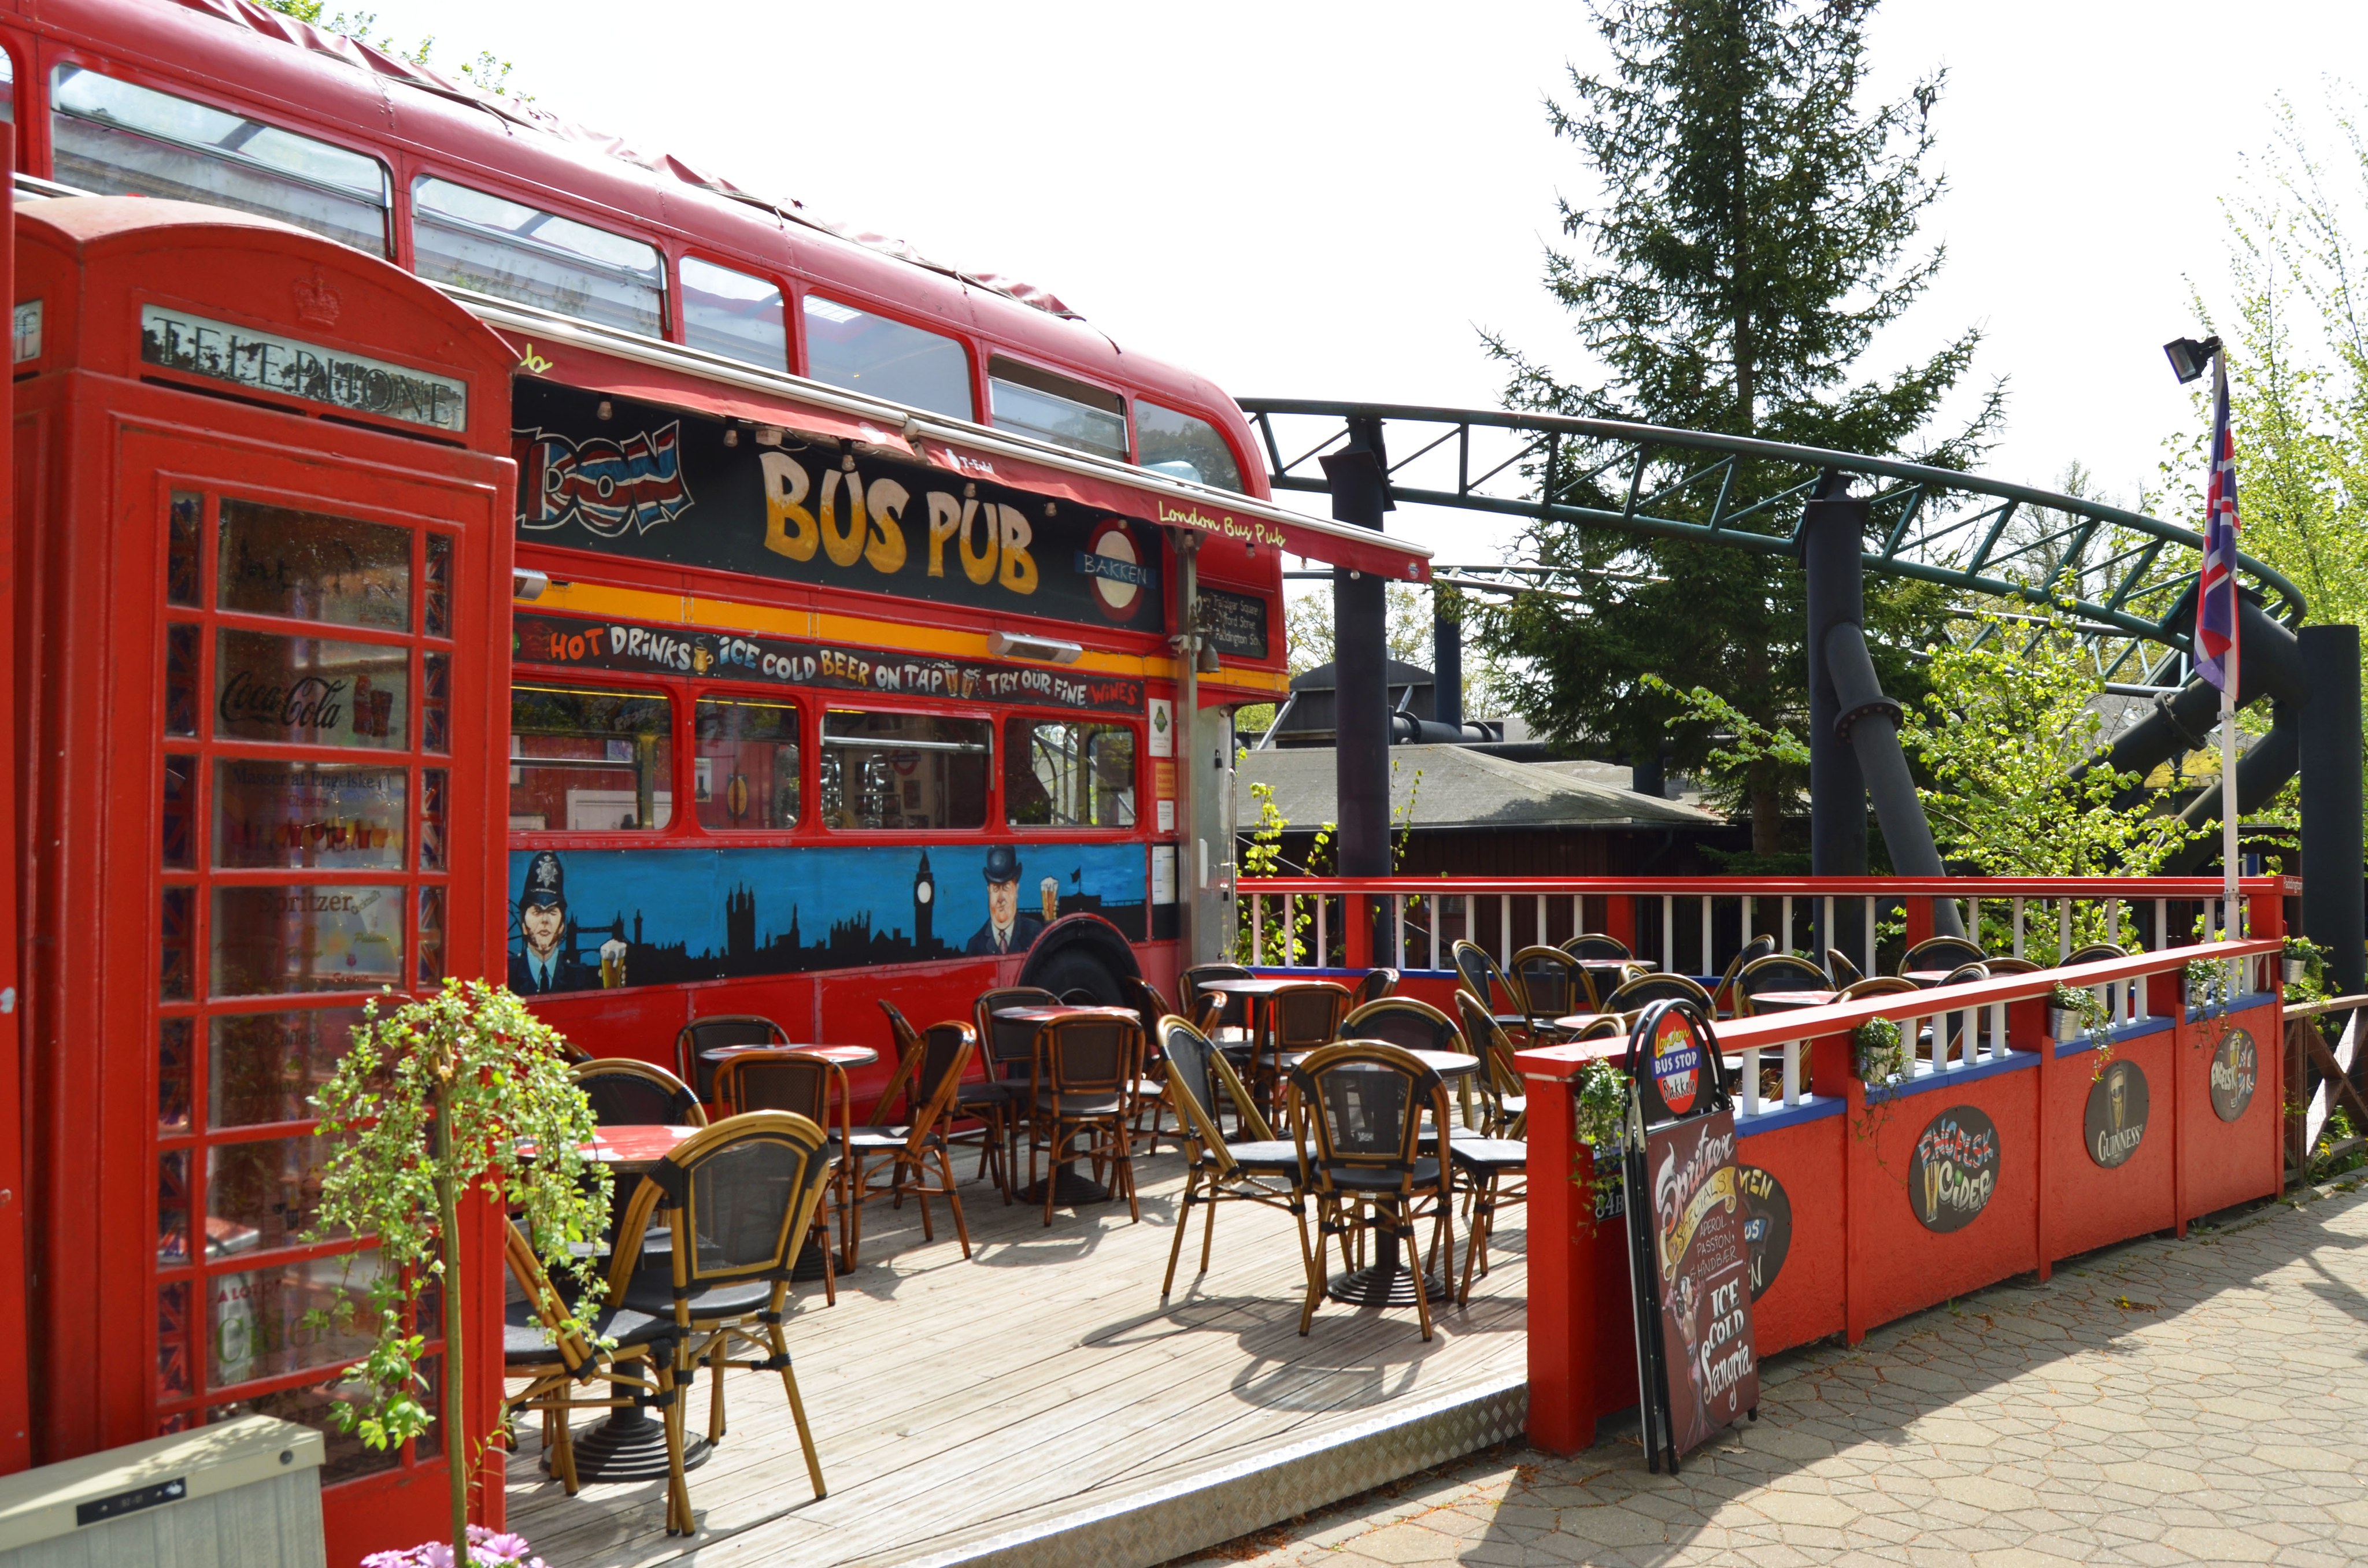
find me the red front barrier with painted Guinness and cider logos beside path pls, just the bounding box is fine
[1518,937,2285,1452]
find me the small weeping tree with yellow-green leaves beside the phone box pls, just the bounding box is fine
[313,981,609,1566]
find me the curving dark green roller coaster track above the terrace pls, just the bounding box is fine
[1241,398,2304,680]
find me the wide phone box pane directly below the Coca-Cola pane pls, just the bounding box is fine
[213,758,410,872]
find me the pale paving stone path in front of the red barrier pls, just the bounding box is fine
[1193,1191,2368,1568]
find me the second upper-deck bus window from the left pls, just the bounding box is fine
[412,175,665,336]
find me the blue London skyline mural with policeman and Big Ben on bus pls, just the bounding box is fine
[509,843,1146,995]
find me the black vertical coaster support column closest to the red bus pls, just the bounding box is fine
[1324,419,1390,895]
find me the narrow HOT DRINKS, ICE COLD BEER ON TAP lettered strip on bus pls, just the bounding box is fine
[509,611,1144,716]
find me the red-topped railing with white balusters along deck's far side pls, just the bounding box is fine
[1236,876,2302,976]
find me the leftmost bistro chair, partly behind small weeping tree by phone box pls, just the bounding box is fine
[502,1220,682,1511]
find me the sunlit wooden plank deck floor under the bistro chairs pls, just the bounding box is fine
[509,1151,1525,1568]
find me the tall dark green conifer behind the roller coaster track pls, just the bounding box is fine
[1480,0,2001,852]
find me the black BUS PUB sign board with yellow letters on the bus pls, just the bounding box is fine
[512,377,1167,632]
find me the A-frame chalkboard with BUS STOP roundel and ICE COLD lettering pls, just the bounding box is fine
[1622,1002,1759,1476]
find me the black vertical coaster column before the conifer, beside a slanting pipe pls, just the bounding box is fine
[1800,485,1866,885]
